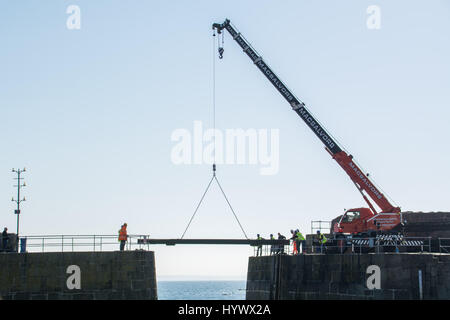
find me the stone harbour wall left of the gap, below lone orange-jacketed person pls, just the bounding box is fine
[0,250,157,300]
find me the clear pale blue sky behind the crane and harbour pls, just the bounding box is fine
[0,0,450,279]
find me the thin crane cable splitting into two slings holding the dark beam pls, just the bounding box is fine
[181,30,248,240]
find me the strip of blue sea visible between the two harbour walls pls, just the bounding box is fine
[157,280,246,300]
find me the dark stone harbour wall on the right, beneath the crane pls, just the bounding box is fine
[246,253,450,300]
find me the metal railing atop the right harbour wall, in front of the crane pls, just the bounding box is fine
[254,237,442,256]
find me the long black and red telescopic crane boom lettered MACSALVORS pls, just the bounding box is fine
[212,19,400,215]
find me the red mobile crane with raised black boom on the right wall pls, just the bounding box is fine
[212,19,402,236]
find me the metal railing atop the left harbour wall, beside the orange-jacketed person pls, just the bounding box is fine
[19,235,153,252]
